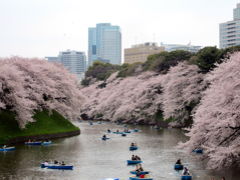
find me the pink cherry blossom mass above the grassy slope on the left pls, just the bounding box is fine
[0,57,84,128]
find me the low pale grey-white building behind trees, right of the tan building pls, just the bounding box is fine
[161,43,202,53]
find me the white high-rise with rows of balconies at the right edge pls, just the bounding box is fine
[219,3,240,48]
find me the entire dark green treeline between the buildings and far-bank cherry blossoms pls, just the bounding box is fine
[82,46,240,86]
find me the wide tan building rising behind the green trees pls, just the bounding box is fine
[124,42,164,64]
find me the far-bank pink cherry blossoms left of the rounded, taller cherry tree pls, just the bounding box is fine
[81,72,163,123]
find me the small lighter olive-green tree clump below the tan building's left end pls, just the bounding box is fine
[118,62,142,77]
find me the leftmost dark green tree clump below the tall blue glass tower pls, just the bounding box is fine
[85,61,120,81]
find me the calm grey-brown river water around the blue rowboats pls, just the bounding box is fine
[0,122,240,180]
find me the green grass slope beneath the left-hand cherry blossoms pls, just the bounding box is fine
[0,111,79,144]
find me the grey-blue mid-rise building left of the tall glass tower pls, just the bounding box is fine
[46,50,86,80]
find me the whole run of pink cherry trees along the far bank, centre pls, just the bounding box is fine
[81,63,203,126]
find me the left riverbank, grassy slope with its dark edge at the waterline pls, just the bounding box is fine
[0,111,80,144]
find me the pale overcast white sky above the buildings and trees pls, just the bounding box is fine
[0,0,240,58]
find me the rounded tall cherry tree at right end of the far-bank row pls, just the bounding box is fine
[162,62,205,127]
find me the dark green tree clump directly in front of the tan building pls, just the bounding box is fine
[143,50,193,73]
